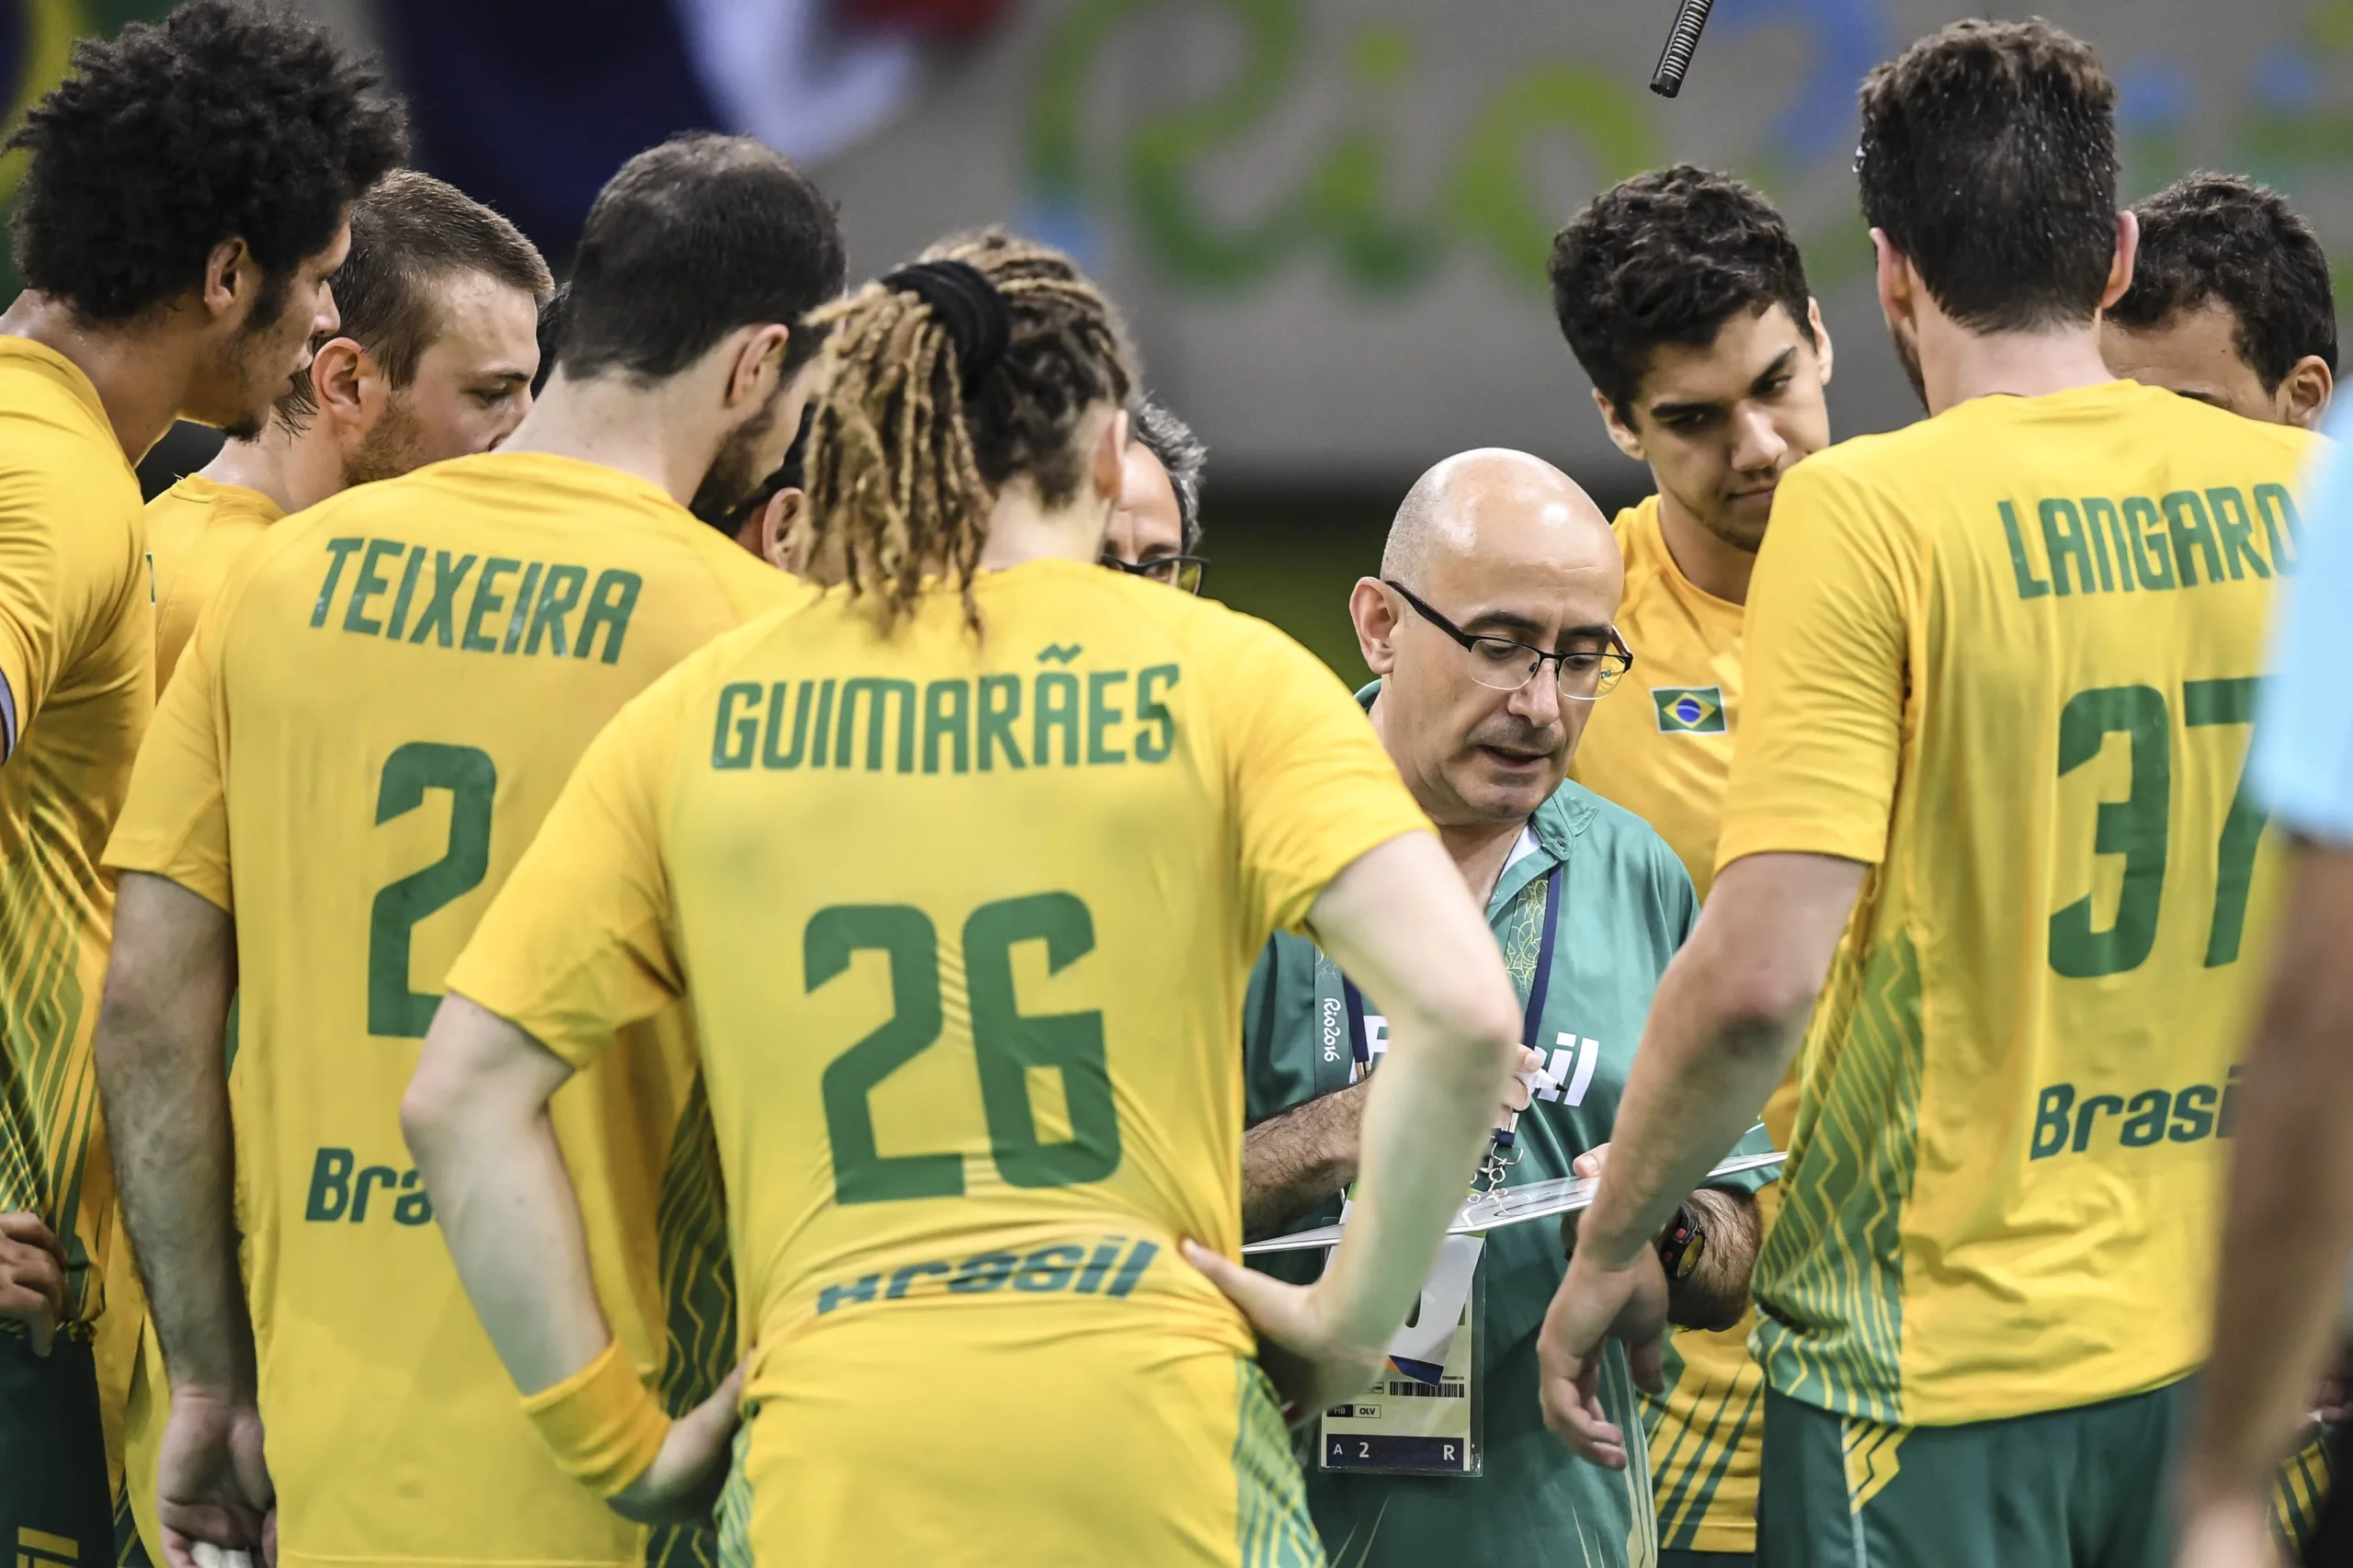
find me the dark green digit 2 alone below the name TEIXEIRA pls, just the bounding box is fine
[367,742,499,1040]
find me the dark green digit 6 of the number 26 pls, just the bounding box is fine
[965,892,1120,1187]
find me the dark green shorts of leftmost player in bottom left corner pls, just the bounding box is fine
[0,1335,115,1568]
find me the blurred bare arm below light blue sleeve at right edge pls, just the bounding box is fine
[2188,850,2353,1500]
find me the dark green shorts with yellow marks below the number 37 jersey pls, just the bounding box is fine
[1757,1380,2190,1568]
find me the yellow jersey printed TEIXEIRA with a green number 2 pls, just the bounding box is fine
[108,452,807,1568]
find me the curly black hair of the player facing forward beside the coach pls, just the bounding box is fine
[1551,163,1814,419]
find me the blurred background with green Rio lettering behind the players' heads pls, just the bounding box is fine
[0,0,2353,668]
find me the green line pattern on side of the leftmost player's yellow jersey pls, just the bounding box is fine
[0,837,104,1321]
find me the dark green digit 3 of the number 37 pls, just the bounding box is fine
[2050,685,2172,980]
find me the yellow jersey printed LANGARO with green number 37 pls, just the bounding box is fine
[1718,381,2315,1425]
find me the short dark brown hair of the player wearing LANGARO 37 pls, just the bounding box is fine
[1854,17,2115,332]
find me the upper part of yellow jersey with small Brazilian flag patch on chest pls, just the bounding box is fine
[1570,496,1744,900]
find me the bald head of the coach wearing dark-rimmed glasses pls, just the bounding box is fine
[1348,449,1631,894]
